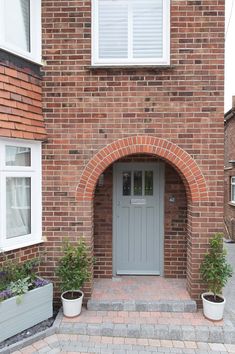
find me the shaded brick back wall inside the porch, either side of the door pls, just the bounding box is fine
[94,157,187,278]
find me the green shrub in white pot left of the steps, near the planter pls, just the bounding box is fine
[56,240,91,317]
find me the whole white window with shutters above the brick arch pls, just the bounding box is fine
[92,0,170,66]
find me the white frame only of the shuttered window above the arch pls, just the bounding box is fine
[91,0,170,67]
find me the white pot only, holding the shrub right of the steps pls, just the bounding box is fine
[202,292,226,321]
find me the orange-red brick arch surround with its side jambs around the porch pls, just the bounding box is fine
[77,136,208,297]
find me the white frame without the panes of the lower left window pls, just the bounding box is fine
[0,139,42,251]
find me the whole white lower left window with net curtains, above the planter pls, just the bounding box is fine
[0,139,42,251]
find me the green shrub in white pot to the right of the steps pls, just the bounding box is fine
[200,233,232,321]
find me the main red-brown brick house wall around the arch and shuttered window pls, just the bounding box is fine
[42,0,224,298]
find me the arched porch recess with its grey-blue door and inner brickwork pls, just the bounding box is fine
[94,154,187,278]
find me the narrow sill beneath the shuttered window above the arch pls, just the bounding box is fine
[86,64,175,71]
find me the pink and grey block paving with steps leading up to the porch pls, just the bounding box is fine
[7,245,235,354]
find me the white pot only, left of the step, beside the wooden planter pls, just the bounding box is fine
[61,290,84,317]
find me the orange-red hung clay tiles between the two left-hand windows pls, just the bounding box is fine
[0,56,46,140]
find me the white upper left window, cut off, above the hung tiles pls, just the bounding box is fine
[0,0,41,62]
